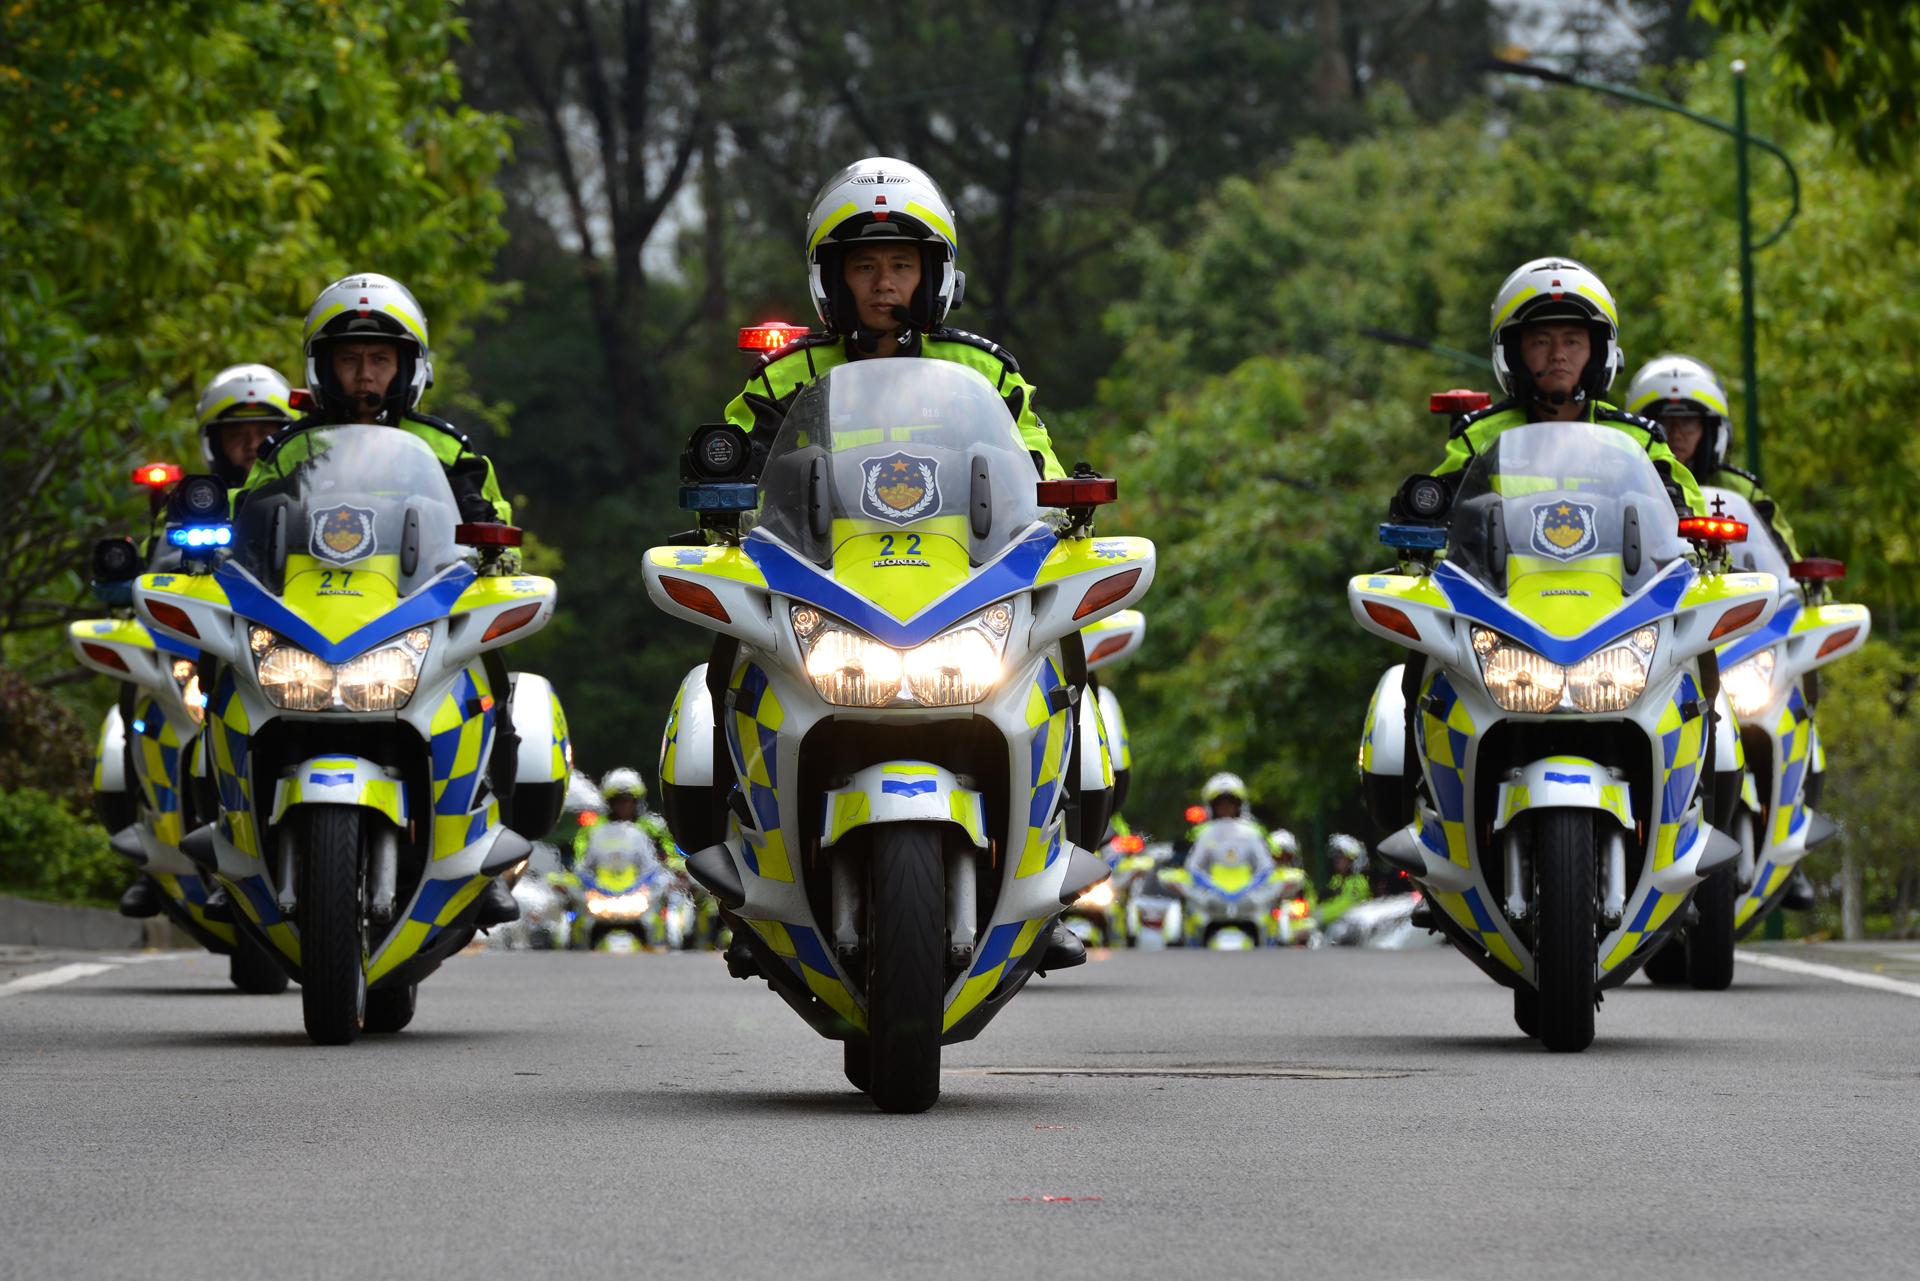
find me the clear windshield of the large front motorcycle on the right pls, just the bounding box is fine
[1446,423,1688,603]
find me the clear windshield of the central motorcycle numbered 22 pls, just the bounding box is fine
[758,359,1039,570]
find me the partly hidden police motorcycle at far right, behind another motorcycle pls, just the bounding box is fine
[1647,488,1872,991]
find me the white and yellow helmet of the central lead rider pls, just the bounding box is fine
[806,156,966,334]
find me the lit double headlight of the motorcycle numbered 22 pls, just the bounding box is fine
[791,601,1014,707]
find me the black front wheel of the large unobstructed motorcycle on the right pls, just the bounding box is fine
[1534,810,1599,1054]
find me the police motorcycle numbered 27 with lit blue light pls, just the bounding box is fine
[132,426,570,1045]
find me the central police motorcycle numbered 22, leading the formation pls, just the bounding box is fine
[645,361,1154,1112]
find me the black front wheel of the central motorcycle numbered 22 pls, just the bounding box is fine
[864,822,947,1112]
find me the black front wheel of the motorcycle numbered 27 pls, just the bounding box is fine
[292,805,367,1045]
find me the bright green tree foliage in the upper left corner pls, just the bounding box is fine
[0,0,507,663]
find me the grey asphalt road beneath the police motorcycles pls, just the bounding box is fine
[0,937,1920,1281]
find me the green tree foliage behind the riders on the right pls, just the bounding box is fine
[1064,50,1920,856]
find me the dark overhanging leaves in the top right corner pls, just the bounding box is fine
[1693,0,1920,167]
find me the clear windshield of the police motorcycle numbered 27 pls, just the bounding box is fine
[234,424,468,613]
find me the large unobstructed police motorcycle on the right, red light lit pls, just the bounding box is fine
[1348,423,1778,1051]
